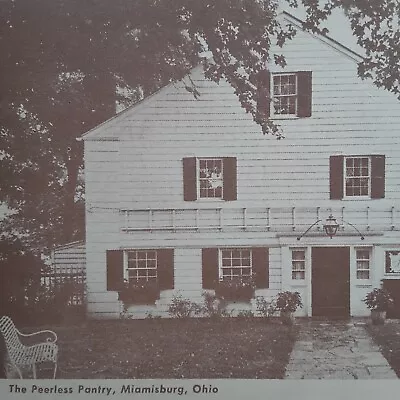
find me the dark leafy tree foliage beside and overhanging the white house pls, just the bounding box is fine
[0,0,399,252]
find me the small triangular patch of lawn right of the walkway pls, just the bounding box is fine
[367,320,400,378]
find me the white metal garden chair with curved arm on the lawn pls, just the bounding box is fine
[0,316,58,379]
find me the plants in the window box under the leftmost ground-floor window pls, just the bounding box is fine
[118,280,160,305]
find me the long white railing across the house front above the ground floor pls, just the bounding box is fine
[120,206,400,233]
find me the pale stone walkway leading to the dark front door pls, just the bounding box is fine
[285,320,397,379]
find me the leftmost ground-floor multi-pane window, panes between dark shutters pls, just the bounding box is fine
[128,250,157,283]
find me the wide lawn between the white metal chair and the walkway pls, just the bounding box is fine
[52,318,298,379]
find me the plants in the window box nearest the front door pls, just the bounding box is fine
[215,277,255,301]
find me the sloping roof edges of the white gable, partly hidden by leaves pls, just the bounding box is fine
[77,11,363,141]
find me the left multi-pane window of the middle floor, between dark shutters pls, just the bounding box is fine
[198,158,224,198]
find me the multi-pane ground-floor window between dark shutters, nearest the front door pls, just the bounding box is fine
[220,249,252,280]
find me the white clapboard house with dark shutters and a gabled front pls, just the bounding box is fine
[82,13,400,318]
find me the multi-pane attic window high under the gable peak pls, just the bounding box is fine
[272,74,298,115]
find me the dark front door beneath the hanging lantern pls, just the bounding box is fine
[311,247,350,317]
